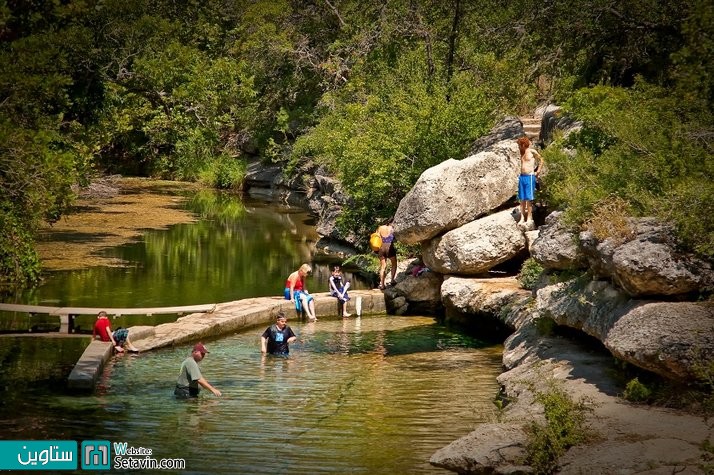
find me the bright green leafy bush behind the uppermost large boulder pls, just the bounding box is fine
[293,46,492,234]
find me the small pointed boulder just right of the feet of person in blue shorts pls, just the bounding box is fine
[530,211,586,270]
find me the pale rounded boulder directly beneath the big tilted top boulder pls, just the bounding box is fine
[422,210,526,275]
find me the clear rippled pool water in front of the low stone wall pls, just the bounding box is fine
[0,316,501,474]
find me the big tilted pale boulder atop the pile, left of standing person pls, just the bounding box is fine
[393,140,520,244]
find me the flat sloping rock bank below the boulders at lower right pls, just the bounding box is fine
[431,304,714,475]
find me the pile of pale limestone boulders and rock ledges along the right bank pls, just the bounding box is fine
[385,114,714,474]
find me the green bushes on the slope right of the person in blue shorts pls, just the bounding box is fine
[546,81,714,255]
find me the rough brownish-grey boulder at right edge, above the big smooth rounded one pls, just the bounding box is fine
[580,218,714,297]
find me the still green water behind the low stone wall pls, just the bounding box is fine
[0,190,370,331]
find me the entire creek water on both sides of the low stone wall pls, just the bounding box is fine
[0,182,502,474]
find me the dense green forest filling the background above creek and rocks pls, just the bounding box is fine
[0,0,714,287]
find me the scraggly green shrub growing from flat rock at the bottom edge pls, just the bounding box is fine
[526,384,589,474]
